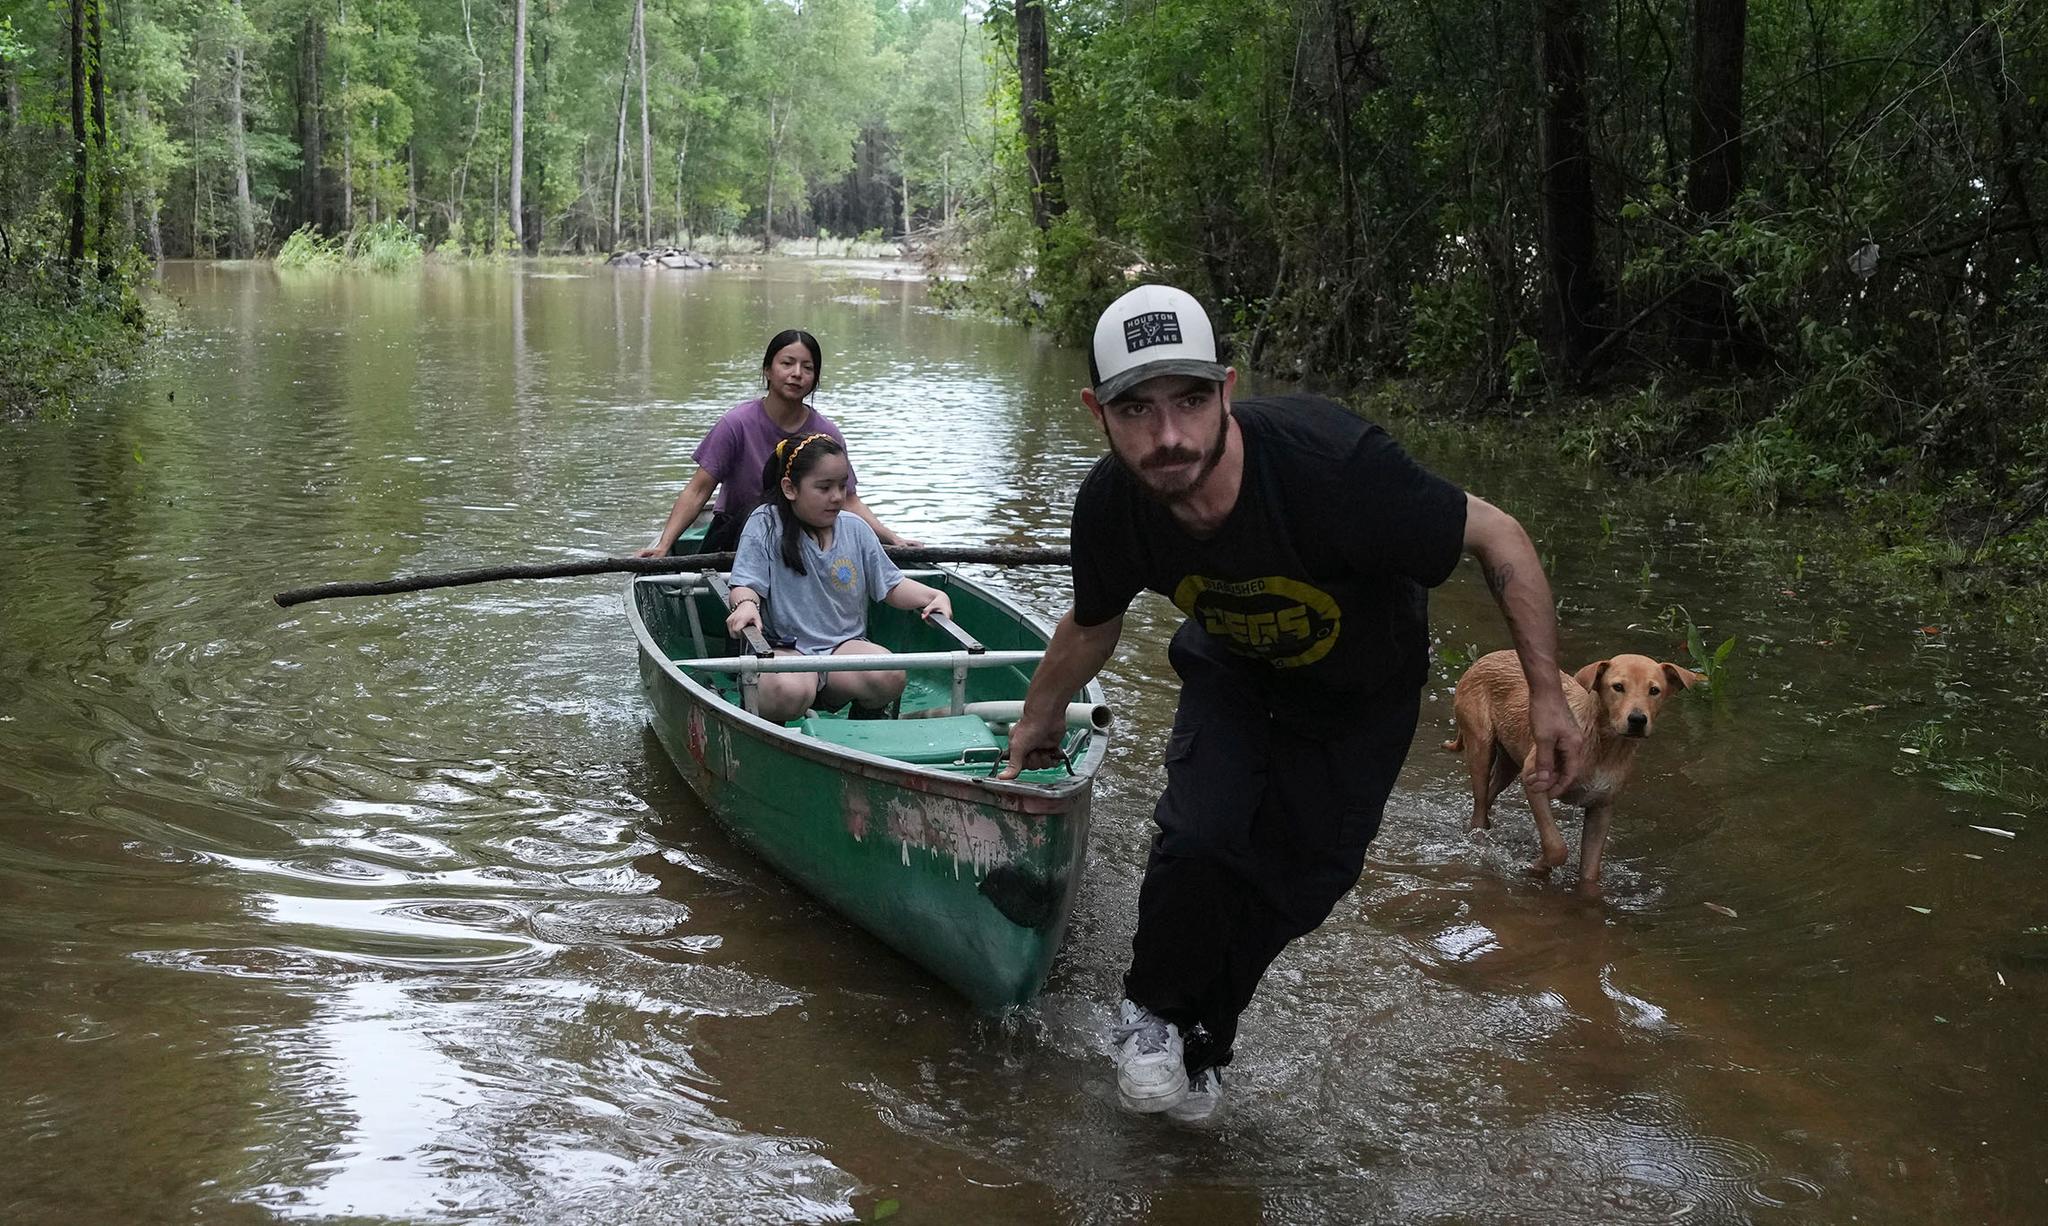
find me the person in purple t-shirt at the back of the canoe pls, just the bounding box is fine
[637,327,918,557]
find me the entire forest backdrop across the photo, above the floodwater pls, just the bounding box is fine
[0,0,2048,614]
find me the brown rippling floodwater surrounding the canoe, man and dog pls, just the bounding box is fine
[0,264,2048,1224]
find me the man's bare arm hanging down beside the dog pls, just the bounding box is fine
[1464,493,1585,796]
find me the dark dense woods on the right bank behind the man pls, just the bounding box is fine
[973,0,2048,601]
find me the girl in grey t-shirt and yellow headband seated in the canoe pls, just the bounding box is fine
[725,432,952,723]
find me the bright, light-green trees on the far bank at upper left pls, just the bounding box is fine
[0,0,991,256]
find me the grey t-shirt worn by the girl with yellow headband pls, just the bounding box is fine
[733,503,903,655]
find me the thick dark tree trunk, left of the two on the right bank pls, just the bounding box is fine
[1538,0,1608,379]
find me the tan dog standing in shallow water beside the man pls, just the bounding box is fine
[1444,651,1706,892]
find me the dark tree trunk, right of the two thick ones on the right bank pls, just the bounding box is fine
[1677,0,1749,370]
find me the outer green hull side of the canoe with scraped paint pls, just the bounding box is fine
[627,579,1104,1009]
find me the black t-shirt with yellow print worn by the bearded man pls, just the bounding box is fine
[1071,395,1464,714]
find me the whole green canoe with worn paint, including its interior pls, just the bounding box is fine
[627,569,1108,1009]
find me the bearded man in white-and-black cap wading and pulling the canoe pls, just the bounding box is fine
[1006,284,1583,1122]
